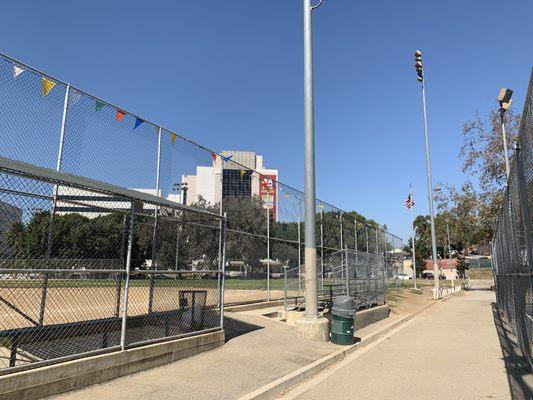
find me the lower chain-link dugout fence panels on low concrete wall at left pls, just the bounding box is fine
[0,157,224,374]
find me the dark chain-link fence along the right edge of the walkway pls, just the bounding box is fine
[492,71,533,371]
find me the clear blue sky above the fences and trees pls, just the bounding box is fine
[0,0,533,238]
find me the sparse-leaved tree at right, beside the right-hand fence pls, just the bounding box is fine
[430,106,520,253]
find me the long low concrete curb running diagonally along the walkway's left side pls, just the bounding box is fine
[238,301,439,400]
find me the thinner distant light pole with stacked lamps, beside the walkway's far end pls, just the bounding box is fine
[415,50,439,298]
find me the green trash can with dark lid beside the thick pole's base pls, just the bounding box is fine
[330,296,355,345]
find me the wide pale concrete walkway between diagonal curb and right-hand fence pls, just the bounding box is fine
[283,290,512,400]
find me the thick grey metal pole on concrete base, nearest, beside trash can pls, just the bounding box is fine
[298,0,328,341]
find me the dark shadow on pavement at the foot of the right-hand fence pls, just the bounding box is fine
[492,303,533,400]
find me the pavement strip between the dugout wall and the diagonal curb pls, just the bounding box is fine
[52,288,433,400]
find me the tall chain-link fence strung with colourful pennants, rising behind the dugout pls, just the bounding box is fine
[0,50,403,303]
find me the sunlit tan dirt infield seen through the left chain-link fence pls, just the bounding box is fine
[0,280,290,331]
